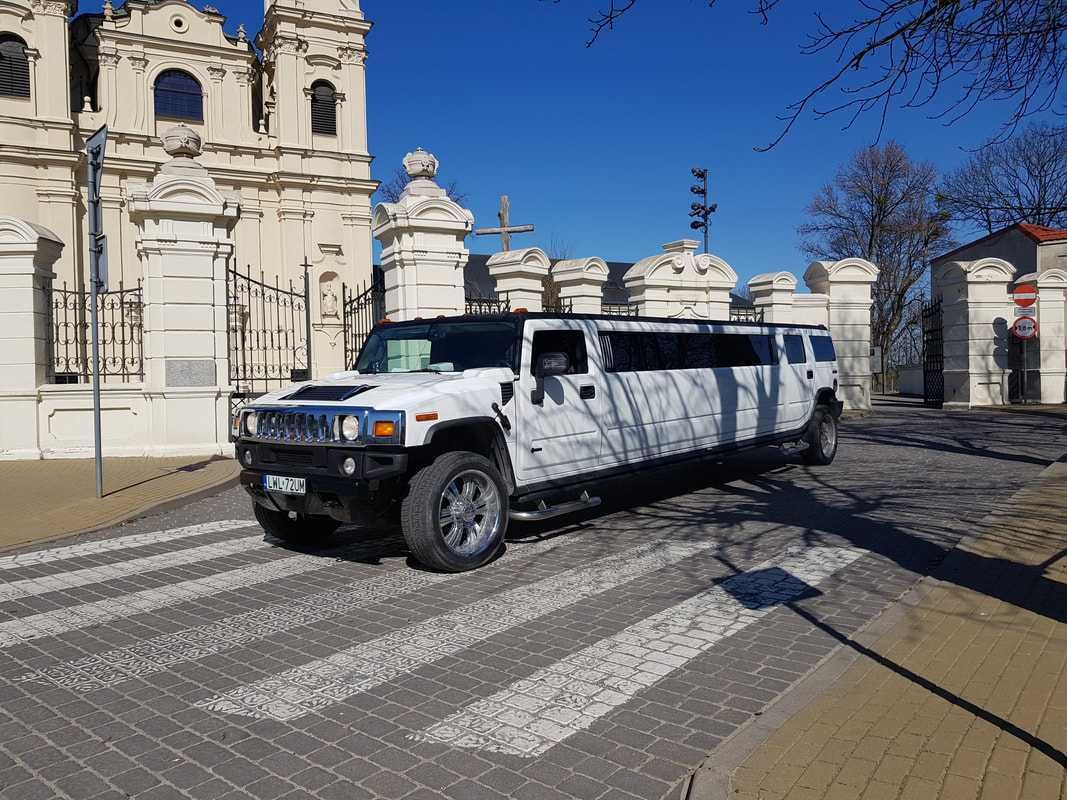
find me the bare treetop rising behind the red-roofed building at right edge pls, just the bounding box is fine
[939,125,1067,234]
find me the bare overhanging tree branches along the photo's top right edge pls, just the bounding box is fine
[554,0,1067,150]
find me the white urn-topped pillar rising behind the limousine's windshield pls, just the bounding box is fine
[373,149,474,320]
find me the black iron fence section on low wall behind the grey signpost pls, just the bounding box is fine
[50,281,144,383]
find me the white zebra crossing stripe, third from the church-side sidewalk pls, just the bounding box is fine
[0,544,403,649]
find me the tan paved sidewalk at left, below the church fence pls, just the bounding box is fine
[0,458,240,549]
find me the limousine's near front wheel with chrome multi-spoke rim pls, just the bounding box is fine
[400,451,508,572]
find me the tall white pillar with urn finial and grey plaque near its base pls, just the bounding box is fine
[130,126,238,455]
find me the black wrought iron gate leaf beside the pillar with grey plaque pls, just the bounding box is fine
[226,267,312,411]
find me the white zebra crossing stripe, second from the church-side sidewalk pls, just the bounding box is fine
[0,534,270,602]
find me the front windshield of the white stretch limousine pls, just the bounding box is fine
[353,321,519,374]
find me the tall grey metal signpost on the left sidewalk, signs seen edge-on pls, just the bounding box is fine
[85,125,108,497]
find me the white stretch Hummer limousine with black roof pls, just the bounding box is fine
[234,313,841,571]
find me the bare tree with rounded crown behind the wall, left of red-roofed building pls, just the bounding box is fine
[797,142,954,381]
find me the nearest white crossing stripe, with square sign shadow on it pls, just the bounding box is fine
[410,547,864,757]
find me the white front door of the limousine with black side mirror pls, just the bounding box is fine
[515,319,603,484]
